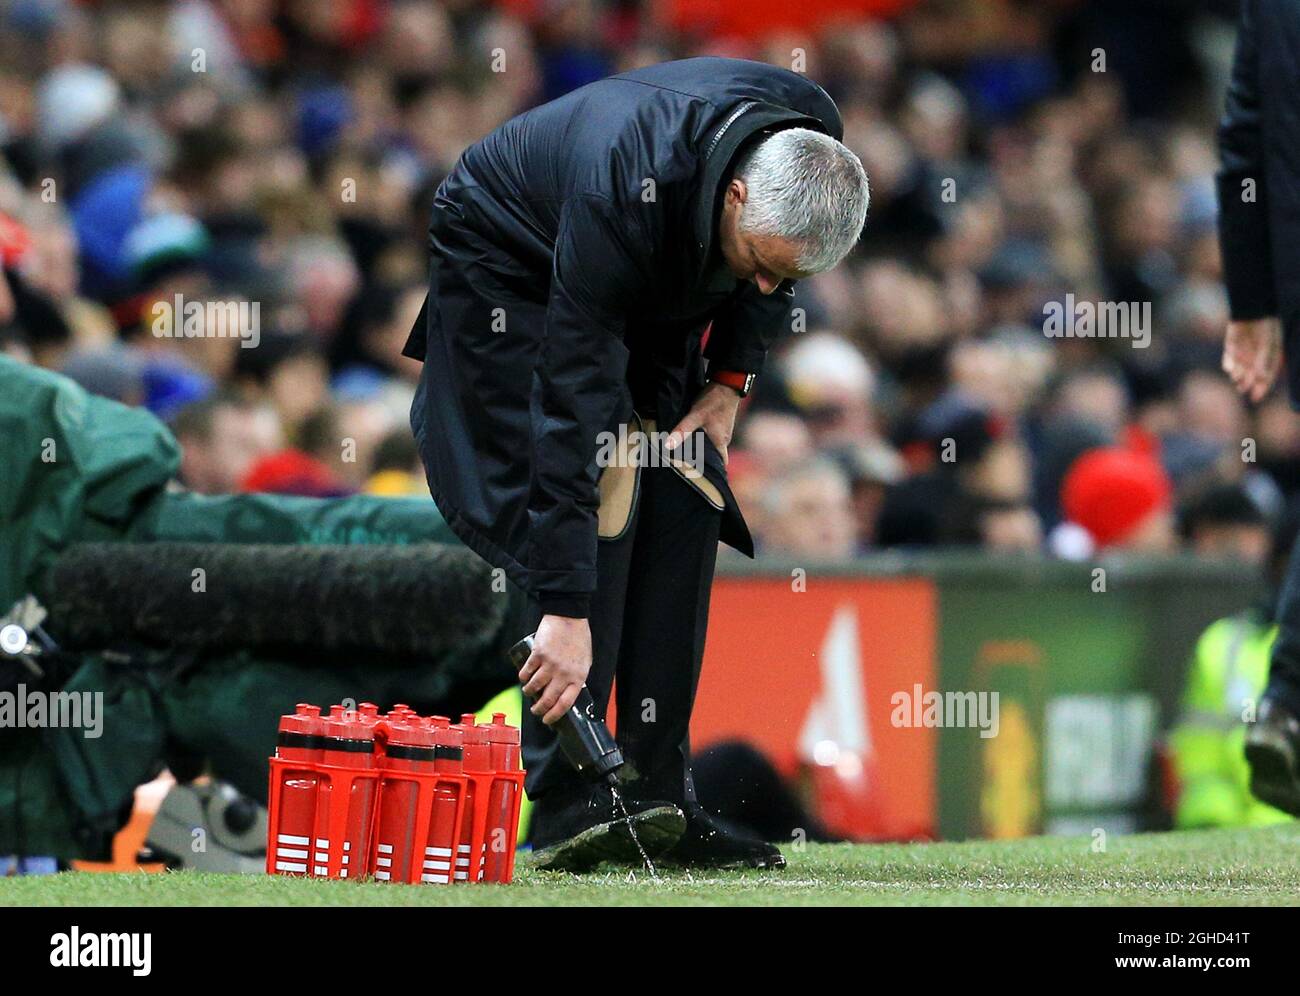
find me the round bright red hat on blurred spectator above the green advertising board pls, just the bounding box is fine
[1061,446,1173,546]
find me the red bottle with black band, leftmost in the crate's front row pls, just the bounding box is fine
[267,702,324,875]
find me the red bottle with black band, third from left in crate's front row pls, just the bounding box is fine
[373,720,437,882]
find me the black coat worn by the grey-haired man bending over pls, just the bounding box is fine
[406,59,842,615]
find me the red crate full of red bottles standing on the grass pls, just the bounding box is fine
[267,702,524,884]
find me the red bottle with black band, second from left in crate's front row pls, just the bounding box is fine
[312,706,378,879]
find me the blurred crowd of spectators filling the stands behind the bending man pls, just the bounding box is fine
[0,0,1279,572]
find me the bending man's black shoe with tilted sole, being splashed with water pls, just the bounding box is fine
[533,791,686,872]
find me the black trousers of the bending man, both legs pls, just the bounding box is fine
[523,457,722,832]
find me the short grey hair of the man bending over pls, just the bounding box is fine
[735,127,871,273]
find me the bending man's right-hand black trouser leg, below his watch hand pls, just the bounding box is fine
[615,468,722,805]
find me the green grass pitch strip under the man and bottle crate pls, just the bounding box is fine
[0,824,1300,906]
